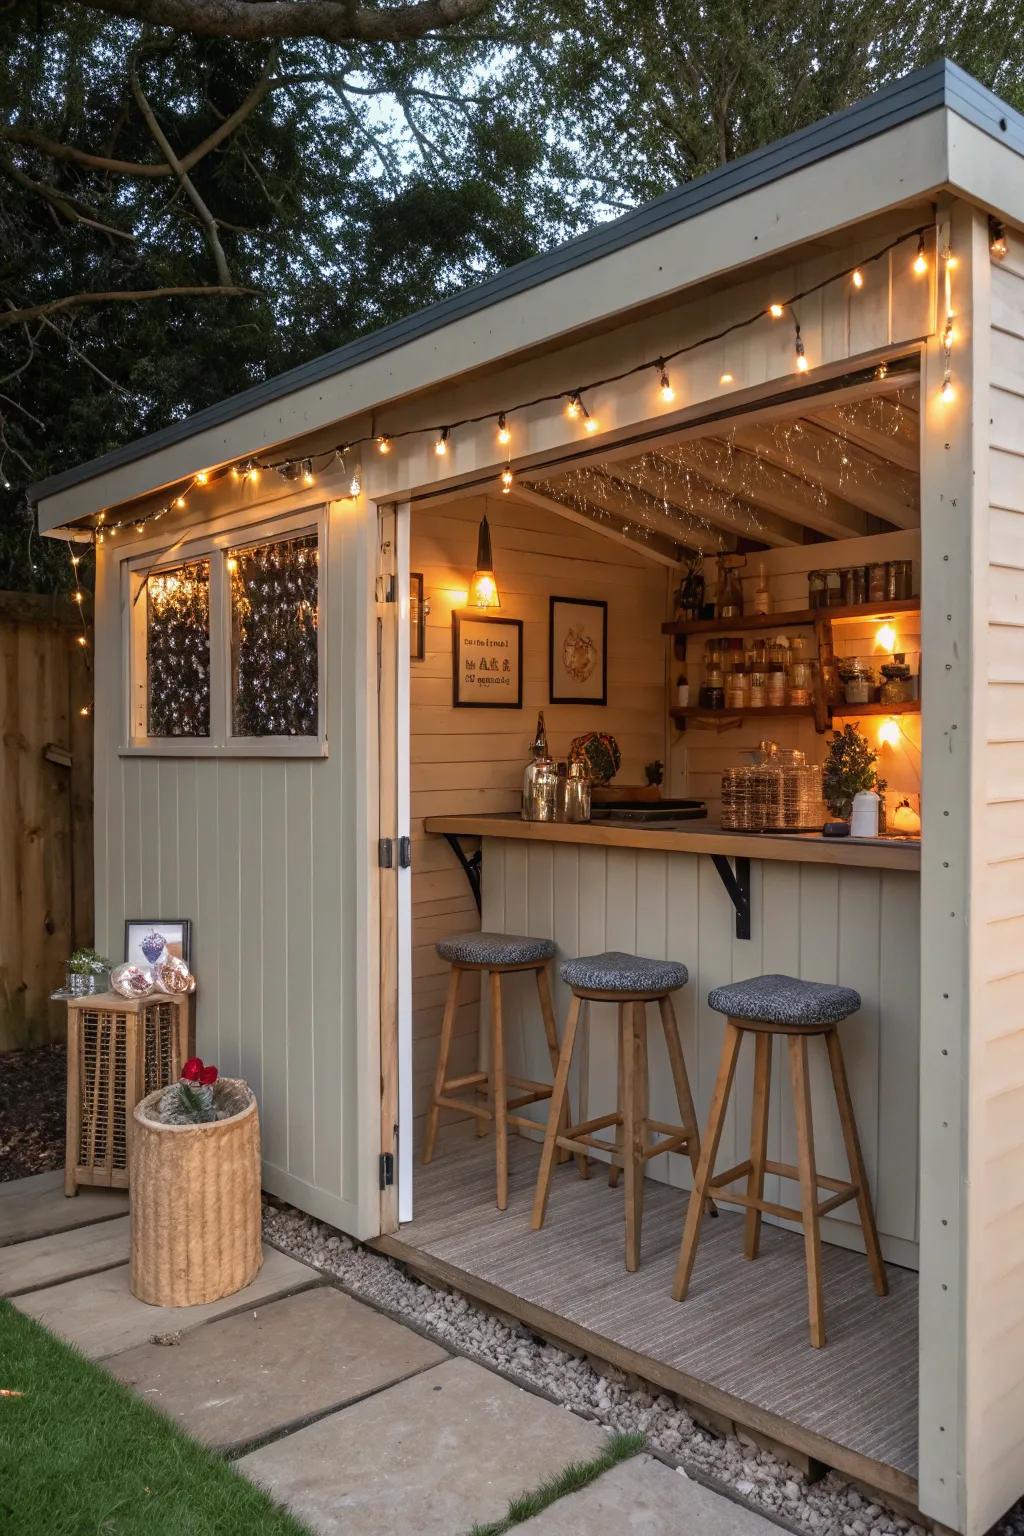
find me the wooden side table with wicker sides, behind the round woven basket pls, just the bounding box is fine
[64,992,189,1195]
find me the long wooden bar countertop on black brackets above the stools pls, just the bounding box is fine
[424,811,921,874]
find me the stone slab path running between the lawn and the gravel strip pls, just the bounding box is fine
[0,1175,778,1536]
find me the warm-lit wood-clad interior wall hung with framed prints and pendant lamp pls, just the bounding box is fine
[410,495,669,1146]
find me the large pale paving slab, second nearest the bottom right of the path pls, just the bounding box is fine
[235,1359,606,1536]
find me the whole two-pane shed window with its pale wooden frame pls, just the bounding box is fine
[123,508,327,757]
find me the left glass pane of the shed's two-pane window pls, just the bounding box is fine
[146,561,210,736]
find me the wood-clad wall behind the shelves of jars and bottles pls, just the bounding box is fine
[671,528,921,817]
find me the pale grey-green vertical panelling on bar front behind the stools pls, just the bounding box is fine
[482,837,920,1267]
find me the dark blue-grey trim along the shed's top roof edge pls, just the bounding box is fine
[29,58,1024,501]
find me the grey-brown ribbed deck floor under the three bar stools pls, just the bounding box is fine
[379,1137,918,1499]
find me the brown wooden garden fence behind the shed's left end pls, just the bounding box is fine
[0,591,92,1051]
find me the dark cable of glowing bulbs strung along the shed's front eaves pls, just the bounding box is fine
[72,223,952,544]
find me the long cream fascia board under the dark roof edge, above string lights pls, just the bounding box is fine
[38,109,947,531]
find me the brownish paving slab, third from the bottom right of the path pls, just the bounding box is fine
[107,1286,448,1450]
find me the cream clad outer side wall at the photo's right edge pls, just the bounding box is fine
[966,224,1024,1528]
